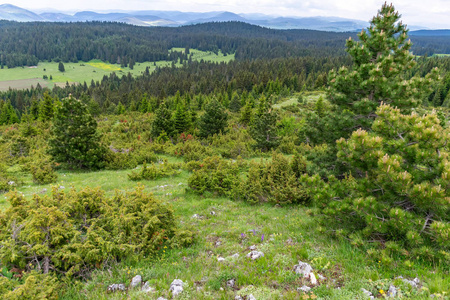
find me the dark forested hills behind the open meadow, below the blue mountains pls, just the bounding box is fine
[0,21,450,67]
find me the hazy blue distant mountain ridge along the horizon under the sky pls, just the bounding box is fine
[0,4,436,32]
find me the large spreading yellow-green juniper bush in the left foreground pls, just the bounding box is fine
[0,186,192,277]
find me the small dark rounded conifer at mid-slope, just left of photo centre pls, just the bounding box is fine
[198,99,228,138]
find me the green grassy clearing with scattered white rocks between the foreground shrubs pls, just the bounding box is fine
[3,156,450,300]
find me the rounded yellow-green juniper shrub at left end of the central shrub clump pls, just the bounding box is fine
[188,156,239,195]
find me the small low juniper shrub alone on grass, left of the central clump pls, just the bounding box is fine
[128,159,181,181]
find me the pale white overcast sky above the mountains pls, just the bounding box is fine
[5,0,450,28]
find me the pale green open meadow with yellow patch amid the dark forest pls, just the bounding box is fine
[0,48,234,91]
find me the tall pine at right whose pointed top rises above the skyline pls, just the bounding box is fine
[329,3,437,129]
